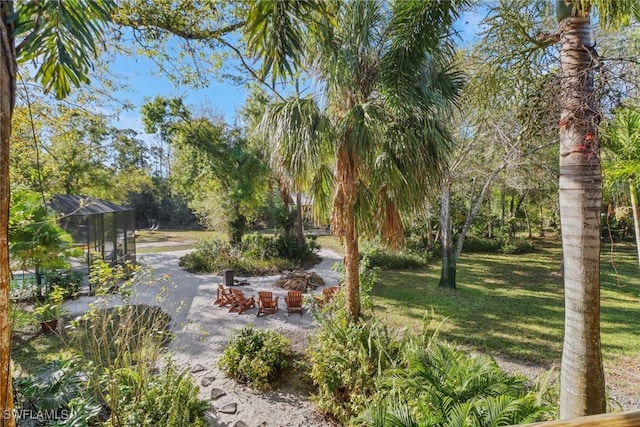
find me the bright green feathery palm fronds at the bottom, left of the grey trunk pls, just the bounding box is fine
[361,337,544,426]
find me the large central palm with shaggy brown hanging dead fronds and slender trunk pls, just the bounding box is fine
[255,1,462,319]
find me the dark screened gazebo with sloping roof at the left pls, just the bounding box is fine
[49,195,136,264]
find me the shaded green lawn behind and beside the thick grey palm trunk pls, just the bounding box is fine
[373,240,640,372]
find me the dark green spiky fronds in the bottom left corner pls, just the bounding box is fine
[14,359,101,427]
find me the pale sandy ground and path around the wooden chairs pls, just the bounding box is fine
[65,250,341,427]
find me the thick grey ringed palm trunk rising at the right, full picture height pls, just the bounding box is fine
[558,9,606,419]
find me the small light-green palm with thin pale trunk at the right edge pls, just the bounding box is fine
[603,108,640,263]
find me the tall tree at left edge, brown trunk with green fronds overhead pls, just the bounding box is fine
[0,0,113,426]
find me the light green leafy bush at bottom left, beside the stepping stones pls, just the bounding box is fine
[104,360,210,427]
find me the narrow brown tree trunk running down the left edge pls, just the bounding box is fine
[0,1,17,427]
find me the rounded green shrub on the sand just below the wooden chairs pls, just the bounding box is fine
[218,326,291,389]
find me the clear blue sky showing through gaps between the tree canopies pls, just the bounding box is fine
[109,8,483,139]
